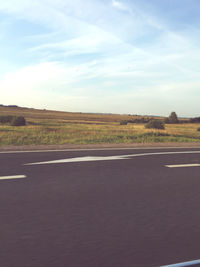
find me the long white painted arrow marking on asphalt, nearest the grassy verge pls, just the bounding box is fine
[24,151,200,165]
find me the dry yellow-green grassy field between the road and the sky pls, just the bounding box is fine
[0,107,200,146]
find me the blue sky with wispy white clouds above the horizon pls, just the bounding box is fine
[0,0,200,117]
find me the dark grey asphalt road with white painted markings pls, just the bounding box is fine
[0,148,200,267]
